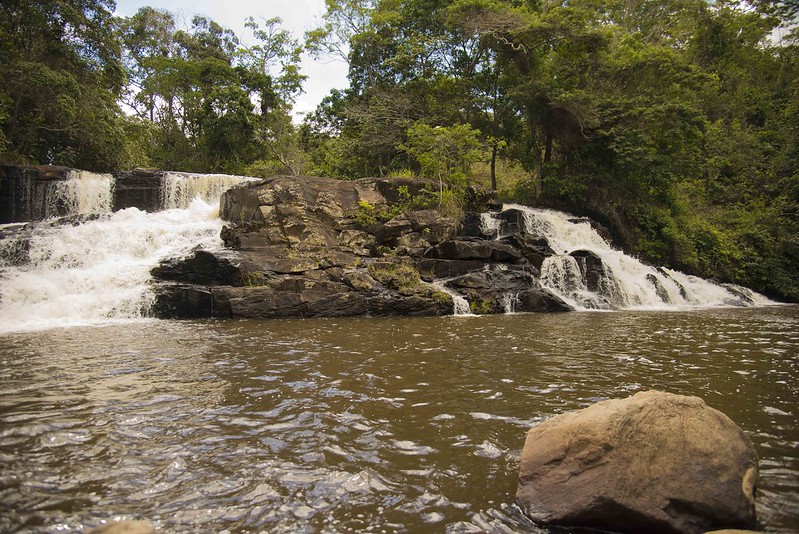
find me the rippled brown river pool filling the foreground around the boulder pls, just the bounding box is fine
[0,307,799,532]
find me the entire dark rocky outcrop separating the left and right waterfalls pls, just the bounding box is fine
[152,176,570,318]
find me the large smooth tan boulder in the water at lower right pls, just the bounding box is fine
[516,391,757,533]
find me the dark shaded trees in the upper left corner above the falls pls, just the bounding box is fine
[0,0,125,170]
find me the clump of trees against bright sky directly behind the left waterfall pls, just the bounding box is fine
[121,7,305,174]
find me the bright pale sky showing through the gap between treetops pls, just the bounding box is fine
[116,0,348,118]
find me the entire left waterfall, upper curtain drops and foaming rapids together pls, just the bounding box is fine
[0,171,255,332]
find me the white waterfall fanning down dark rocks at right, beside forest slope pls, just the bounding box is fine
[484,205,770,309]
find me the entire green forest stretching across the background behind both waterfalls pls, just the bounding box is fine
[0,0,799,300]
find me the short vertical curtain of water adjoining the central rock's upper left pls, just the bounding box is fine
[161,172,258,209]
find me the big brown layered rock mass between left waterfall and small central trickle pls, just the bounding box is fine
[153,176,462,318]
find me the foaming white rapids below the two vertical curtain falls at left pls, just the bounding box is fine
[0,199,222,332]
